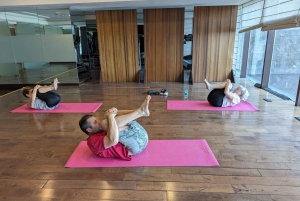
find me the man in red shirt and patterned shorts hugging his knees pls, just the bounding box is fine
[79,95,151,160]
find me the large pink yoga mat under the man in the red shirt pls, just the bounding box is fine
[65,140,219,168]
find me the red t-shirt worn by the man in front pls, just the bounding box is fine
[87,131,131,161]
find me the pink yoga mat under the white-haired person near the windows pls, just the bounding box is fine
[167,100,258,111]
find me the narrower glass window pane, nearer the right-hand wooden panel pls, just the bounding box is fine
[247,29,268,83]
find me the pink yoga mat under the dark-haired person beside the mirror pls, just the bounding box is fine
[10,103,102,113]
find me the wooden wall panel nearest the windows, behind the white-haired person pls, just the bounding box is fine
[192,6,237,82]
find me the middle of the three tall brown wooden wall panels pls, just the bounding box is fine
[143,8,184,82]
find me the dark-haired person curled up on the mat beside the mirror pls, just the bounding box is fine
[22,78,61,110]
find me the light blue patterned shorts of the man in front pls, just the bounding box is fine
[119,121,148,154]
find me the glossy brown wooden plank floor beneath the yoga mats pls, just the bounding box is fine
[0,79,300,201]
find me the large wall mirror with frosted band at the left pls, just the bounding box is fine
[0,9,79,84]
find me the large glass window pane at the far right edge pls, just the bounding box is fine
[269,28,300,101]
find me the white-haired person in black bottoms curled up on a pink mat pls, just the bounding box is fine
[204,79,249,107]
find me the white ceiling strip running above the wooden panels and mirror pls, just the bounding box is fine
[0,0,250,16]
